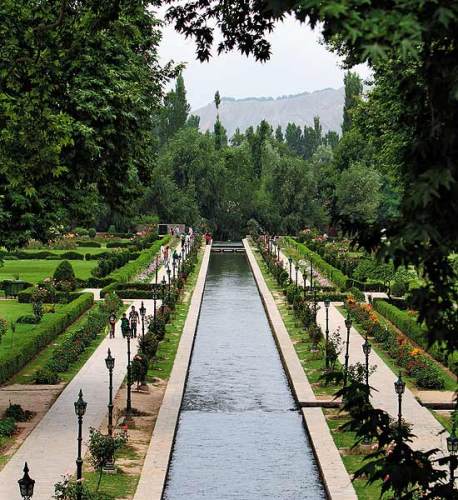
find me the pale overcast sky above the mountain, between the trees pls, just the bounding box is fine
[159,11,370,109]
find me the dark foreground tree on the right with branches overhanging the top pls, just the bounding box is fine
[164,0,458,350]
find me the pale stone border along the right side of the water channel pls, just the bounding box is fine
[243,239,358,500]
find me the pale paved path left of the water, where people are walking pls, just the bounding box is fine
[0,247,177,500]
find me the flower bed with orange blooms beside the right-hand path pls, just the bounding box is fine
[346,296,445,389]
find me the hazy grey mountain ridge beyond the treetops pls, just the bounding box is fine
[192,87,345,135]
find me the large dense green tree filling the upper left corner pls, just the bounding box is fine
[0,0,167,248]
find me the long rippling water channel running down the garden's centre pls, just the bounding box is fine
[163,254,325,500]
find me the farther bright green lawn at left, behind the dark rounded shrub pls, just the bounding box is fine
[0,259,97,283]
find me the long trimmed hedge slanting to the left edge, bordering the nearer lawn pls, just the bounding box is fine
[0,293,94,384]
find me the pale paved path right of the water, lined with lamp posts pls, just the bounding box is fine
[274,244,448,453]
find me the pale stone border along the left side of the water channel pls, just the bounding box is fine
[134,245,211,500]
